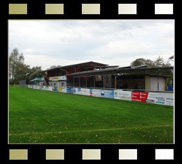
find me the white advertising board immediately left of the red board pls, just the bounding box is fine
[114,90,131,101]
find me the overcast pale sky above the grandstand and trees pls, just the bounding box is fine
[9,20,174,70]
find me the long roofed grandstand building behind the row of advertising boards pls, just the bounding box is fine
[43,61,173,91]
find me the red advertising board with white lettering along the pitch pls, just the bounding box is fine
[131,91,148,102]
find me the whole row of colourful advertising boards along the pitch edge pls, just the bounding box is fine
[28,85,174,106]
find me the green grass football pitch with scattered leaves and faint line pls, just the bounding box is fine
[9,86,173,143]
